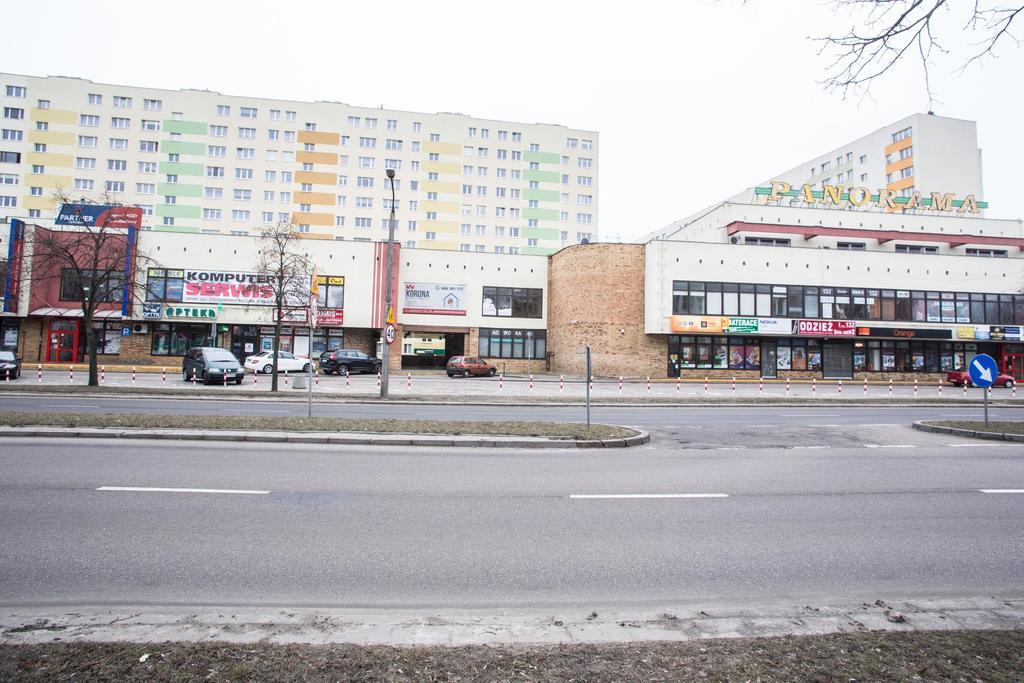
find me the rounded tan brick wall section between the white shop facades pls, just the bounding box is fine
[548,244,668,377]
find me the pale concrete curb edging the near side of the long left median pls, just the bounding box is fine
[0,426,650,449]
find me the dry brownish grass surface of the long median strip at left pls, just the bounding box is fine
[0,412,638,439]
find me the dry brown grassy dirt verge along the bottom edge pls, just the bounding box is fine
[0,631,1024,682]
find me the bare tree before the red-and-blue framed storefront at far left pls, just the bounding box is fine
[19,189,148,386]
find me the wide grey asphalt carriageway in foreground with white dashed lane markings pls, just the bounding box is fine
[0,432,1024,610]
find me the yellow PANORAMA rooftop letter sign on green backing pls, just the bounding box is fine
[754,180,988,214]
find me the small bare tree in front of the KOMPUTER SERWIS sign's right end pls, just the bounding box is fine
[256,223,312,391]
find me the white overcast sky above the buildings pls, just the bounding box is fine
[9,0,1024,240]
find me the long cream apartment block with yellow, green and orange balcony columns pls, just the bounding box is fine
[0,74,599,255]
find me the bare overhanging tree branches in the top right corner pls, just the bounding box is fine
[816,0,1024,104]
